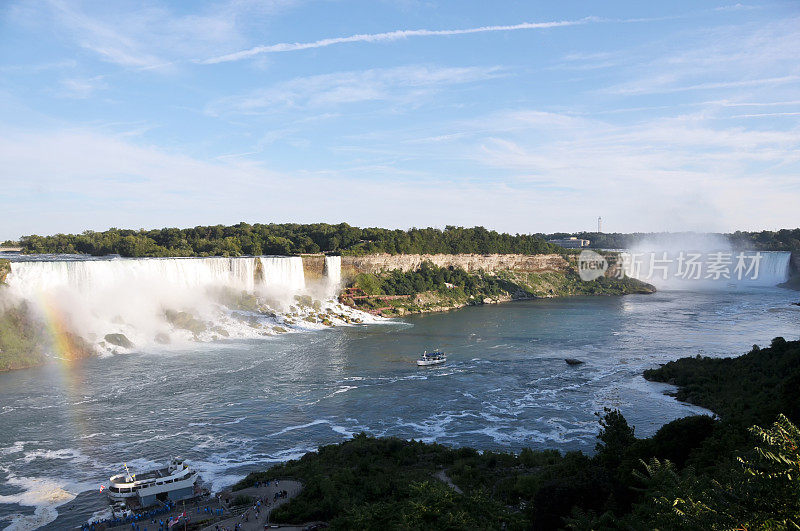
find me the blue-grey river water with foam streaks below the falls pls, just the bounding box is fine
[0,288,800,529]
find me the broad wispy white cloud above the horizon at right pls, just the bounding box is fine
[322,103,800,230]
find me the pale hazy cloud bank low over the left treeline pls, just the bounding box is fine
[0,124,600,238]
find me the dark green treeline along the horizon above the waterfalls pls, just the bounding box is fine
[14,223,800,257]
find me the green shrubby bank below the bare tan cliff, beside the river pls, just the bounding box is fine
[340,262,655,316]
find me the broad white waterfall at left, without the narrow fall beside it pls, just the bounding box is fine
[5,256,312,346]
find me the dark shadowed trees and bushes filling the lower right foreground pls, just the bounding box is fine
[234,338,800,530]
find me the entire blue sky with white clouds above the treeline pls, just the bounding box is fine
[0,0,800,240]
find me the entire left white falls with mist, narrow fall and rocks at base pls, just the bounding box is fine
[7,256,368,352]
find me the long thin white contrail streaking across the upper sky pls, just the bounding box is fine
[200,17,600,64]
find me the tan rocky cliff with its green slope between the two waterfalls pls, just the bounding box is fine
[339,254,655,317]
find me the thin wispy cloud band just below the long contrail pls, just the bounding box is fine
[206,65,504,116]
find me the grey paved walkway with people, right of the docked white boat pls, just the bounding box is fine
[203,479,302,531]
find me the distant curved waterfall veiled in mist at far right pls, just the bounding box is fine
[621,249,791,290]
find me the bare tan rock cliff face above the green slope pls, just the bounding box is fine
[342,254,570,278]
